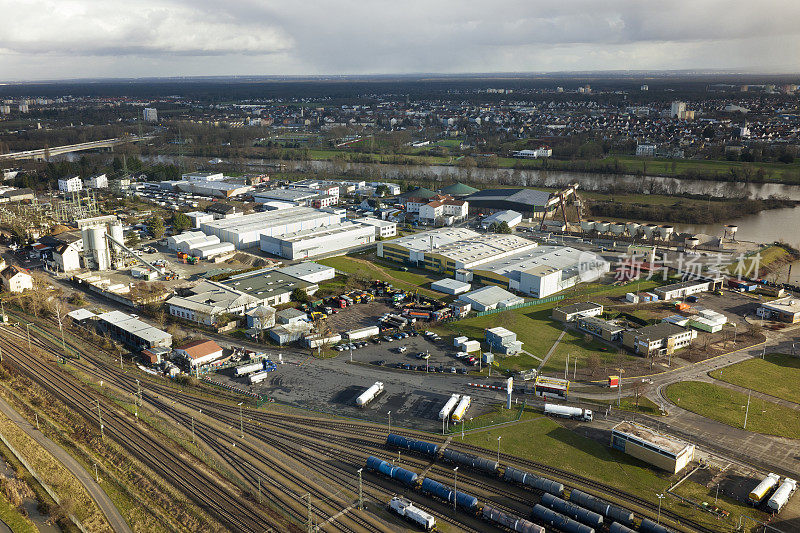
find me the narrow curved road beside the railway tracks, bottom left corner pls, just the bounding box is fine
[0,398,133,533]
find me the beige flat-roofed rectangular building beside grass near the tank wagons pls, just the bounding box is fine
[611,422,694,474]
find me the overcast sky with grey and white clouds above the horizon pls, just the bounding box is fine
[0,0,800,80]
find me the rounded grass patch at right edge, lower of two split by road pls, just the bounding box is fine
[666,381,800,439]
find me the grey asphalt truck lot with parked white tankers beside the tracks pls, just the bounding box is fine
[213,336,522,431]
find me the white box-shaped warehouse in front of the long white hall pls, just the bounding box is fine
[261,221,375,259]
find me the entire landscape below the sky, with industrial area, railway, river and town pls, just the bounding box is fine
[0,71,800,533]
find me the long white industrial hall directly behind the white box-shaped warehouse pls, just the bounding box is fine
[200,207,346,249]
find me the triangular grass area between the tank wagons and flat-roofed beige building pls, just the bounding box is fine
[460,411,764,531]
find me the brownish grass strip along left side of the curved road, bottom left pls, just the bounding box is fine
[0,406,113,532]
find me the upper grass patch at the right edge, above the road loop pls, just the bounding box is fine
[708,354,800,403]
